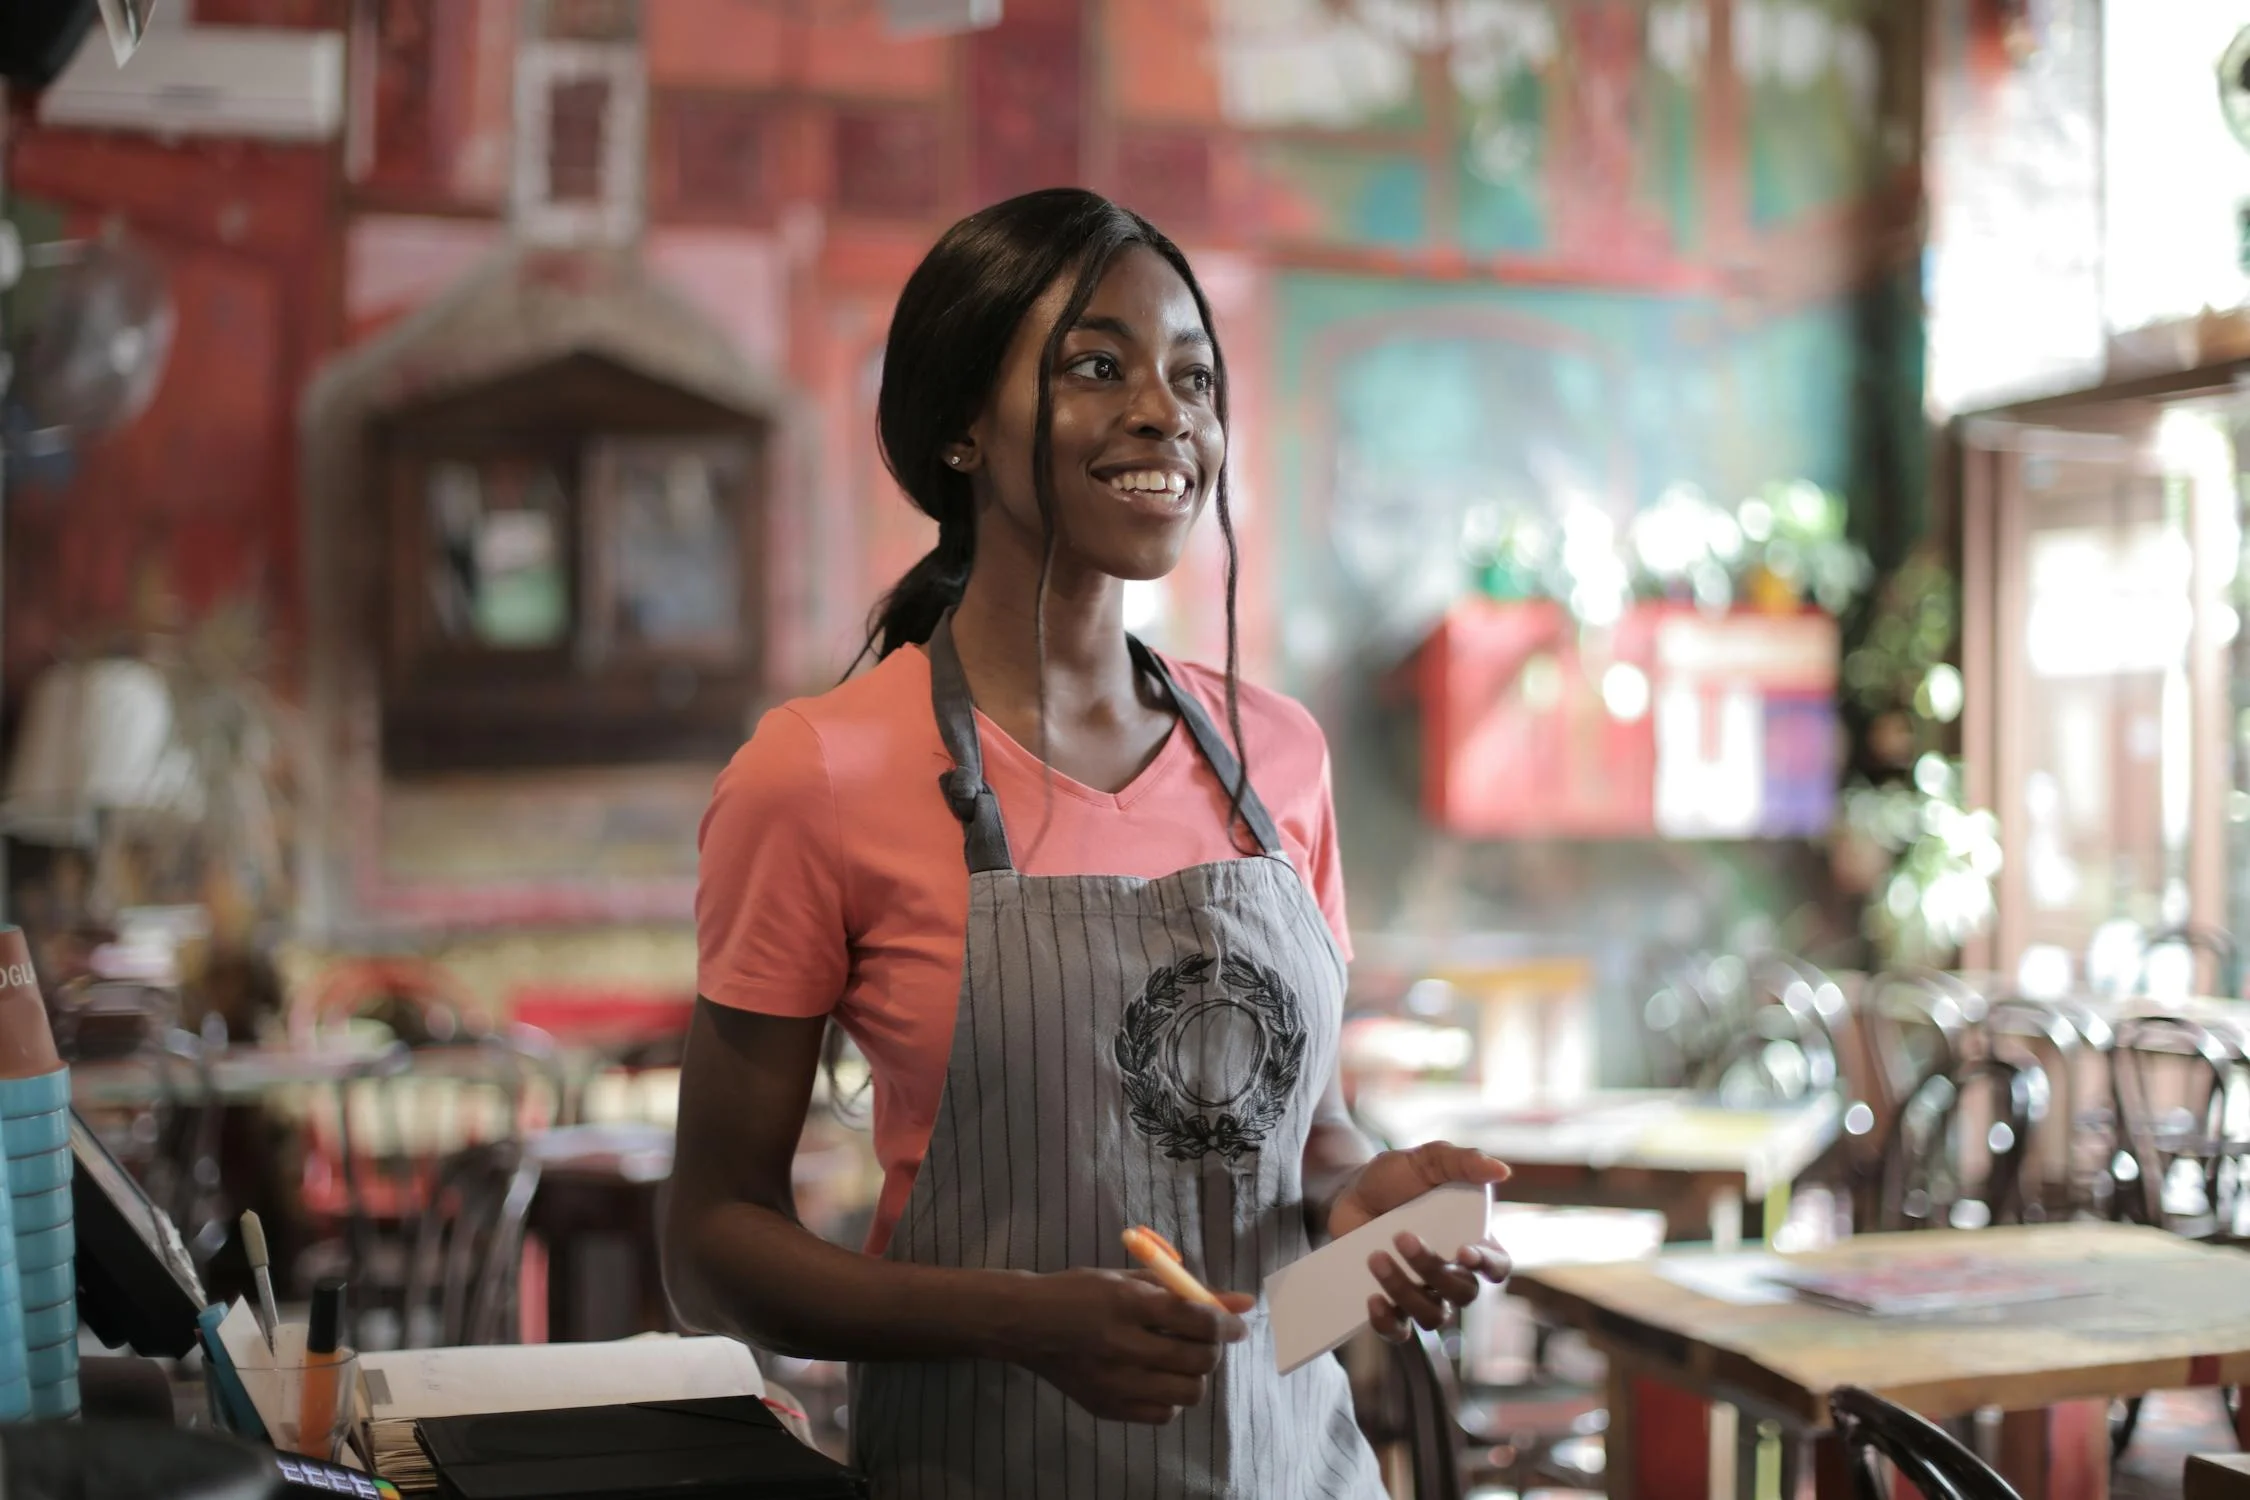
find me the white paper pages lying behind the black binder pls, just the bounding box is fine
[360,1336,765,1421]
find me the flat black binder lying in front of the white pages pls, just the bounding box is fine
[416,1397,866,1500]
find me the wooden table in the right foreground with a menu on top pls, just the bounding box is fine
[1514,1223,2250,1500]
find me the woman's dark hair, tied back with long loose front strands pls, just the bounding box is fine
[860,187,1249,841]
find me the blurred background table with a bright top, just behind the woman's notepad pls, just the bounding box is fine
[1359,1086,1843,1248]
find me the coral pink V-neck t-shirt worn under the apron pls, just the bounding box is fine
[695,650,1350,1253]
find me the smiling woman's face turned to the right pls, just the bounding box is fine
[970,245,1226,578]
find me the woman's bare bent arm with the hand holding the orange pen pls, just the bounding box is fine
[664,1001,1247,1421]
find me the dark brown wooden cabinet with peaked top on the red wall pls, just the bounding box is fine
[378,355,767,771]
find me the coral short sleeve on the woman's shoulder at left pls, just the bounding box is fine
[695,708,851,1016]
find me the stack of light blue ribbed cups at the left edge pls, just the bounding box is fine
[0,1068,79,1419]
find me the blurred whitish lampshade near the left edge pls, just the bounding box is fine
[0,657,194,848]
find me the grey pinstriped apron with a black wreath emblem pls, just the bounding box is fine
[851,621,1384,1500]
